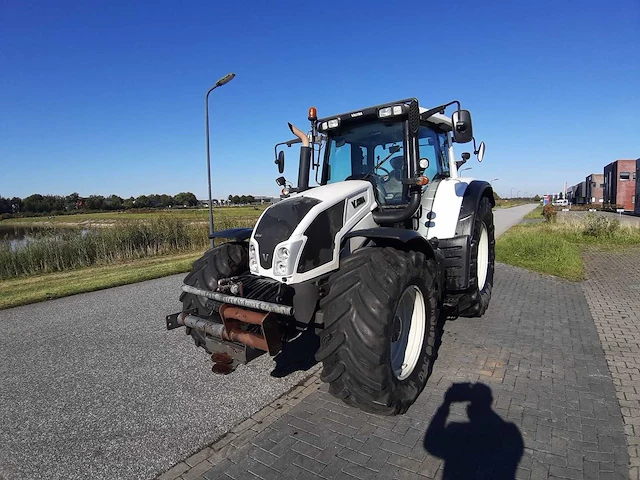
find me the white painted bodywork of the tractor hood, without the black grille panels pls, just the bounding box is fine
[250,180,378,284]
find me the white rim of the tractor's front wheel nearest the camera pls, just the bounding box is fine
[391,285,426,380]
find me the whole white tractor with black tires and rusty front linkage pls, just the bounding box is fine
[166,98,495,415]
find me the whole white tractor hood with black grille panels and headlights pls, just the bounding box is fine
[249,180,376,283]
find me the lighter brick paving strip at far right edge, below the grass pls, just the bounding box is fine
[582,248,640,480]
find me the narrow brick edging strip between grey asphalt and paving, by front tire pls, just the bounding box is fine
[156,365,322,480]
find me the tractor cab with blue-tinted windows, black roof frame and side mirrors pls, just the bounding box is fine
[276,98,484,225]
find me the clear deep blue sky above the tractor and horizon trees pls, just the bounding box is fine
[0,0,640,198]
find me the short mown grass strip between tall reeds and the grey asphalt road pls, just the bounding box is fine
[0,252,202,310]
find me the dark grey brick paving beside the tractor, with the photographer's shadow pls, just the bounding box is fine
[161,264,631,480]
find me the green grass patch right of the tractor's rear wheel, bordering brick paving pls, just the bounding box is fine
[496,216,640,281]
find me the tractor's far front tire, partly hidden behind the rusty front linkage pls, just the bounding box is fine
[180,242,249,348]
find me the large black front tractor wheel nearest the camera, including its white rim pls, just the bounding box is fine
[316,247,439,415]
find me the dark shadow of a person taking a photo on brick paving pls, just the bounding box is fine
[424,383,524,480]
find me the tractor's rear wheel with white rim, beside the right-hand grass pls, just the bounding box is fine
[458,197,496,317]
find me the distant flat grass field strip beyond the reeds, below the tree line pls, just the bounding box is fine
[0,205,266,226]
